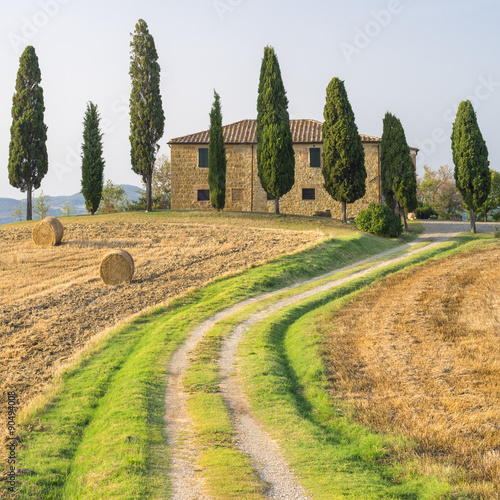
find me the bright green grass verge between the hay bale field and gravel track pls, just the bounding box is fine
[12,213,410,499]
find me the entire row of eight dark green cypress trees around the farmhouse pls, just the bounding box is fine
[8,38,491,232]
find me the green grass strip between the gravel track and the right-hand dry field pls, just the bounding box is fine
[239,237,492,499]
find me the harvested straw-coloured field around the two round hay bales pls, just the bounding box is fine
[0,218,324,438]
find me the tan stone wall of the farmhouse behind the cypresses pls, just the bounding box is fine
[171,143,380,218]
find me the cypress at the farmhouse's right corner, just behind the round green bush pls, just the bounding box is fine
[380,113,417,230]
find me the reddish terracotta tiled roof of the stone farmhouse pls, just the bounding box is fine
[169,120,380,144]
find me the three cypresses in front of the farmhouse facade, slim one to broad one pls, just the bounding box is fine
[209,46,366,221]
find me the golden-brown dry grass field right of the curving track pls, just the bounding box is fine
[324,246,500,498]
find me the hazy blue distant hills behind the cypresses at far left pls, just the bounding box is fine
[0,184,143,225]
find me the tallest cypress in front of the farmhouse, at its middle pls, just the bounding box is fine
[257,46,295,214]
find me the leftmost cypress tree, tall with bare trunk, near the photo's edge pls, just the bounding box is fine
[8,46,49,220]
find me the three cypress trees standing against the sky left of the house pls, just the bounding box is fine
[8,19,165,220]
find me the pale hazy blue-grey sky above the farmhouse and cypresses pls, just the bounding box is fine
[0,0,500,198]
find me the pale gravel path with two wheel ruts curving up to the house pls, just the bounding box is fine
[165,221,495,500]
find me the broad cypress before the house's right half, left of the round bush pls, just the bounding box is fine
[322,78,366,222]
